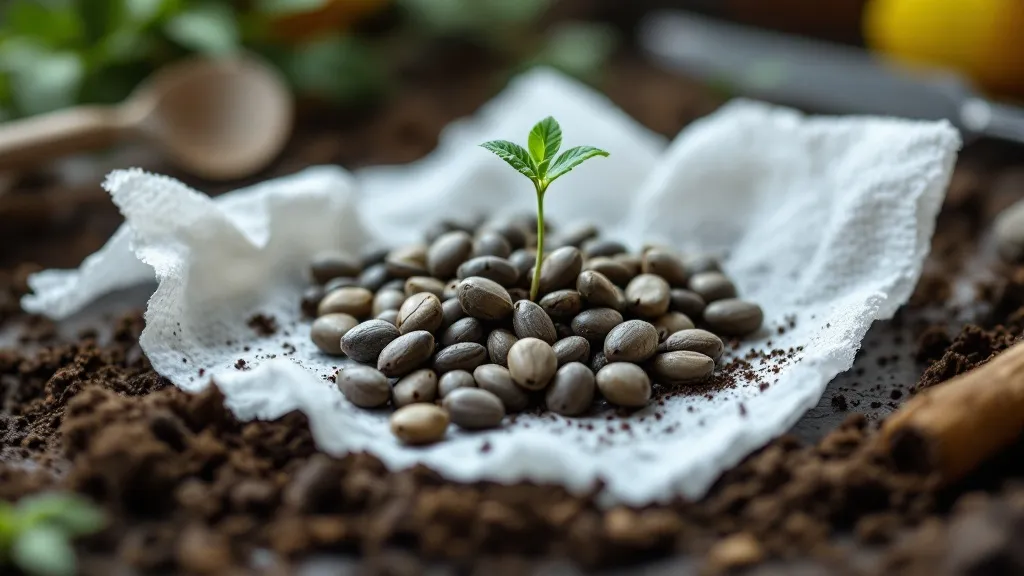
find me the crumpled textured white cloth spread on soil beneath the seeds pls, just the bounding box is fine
[24,71,959,504]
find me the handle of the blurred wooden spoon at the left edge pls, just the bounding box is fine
[0,107,126,169]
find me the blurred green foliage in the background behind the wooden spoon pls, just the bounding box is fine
[0,0,614,120]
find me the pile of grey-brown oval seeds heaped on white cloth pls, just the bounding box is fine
[302,218,763,444]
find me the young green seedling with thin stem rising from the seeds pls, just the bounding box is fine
[480,116,608,300]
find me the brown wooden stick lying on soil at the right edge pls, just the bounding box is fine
[881,342,1024,483]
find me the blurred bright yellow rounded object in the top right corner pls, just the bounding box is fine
[864,0,1024,95]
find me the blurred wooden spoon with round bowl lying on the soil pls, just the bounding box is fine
[0,57,293,180]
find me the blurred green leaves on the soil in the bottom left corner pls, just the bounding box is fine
[0,493,106,576]
